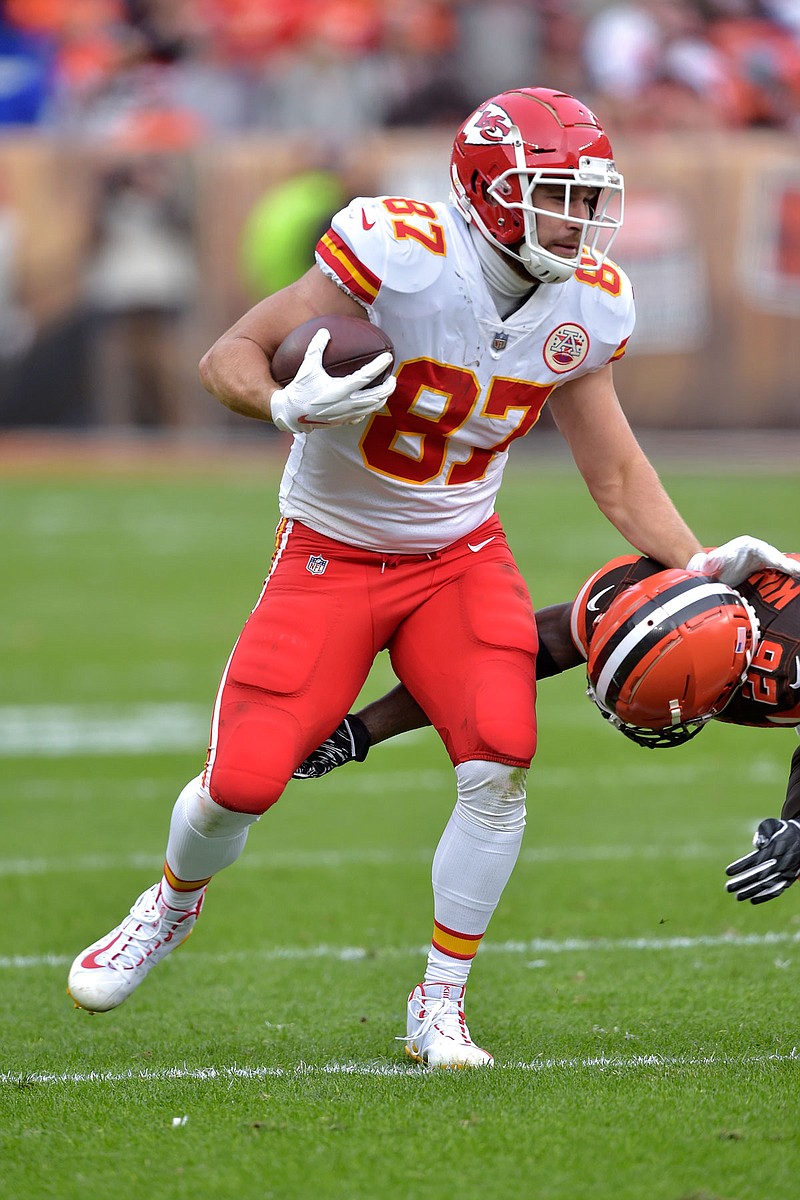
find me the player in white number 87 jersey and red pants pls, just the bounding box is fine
[70,88,782,1067]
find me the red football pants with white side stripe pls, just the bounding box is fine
[204,516,537,812]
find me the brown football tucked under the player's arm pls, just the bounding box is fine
[271,316,395,386]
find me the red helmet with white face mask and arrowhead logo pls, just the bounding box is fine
[450,88,624,283]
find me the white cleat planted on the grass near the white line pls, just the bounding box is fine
[401,983,494,1070]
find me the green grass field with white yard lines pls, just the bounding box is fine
[0,457,800,1200]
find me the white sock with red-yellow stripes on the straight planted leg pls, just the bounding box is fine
[425,761,527,985]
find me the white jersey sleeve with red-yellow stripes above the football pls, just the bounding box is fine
[317,196,445,308]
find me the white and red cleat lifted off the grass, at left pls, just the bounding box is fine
[67,883,205,1013]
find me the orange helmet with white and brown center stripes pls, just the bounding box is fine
[588,570,759,749]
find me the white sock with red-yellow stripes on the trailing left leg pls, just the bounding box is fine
[161,776,258,908]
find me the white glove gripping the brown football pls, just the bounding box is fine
[270,329,397,433]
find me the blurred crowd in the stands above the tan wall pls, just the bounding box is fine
[0,0,800,140]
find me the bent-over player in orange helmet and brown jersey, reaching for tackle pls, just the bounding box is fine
[295,552,800,904]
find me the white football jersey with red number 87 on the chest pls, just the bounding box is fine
[281,197,633,553]
